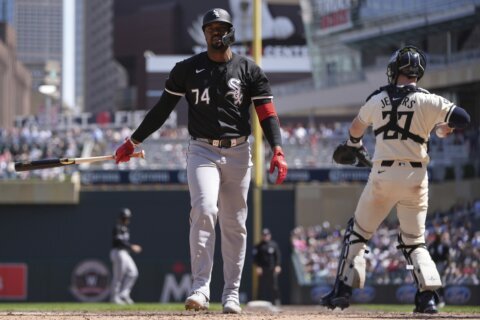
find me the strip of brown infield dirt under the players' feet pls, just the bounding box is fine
[0,306,480,320]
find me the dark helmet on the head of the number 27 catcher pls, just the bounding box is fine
[387,46,427,84]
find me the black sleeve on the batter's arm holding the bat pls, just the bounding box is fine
[132,91,181,143]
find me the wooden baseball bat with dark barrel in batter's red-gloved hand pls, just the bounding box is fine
[15,150,145,172]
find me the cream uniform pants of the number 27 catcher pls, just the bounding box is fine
[343,161,431,286]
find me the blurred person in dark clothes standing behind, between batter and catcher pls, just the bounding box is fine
[253,229,282,306]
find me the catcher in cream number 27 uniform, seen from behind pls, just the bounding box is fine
[321,46,470,313]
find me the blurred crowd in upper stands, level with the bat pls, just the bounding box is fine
[0,121,480,179]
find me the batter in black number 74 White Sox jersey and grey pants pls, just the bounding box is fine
[115,8,287,313]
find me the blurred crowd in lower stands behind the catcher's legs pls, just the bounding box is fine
[291,199,480,285]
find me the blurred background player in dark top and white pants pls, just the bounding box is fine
[110,208,142,304]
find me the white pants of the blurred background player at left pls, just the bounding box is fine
[110,249,138,300]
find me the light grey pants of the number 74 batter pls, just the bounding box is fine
[187,140,252,303]
